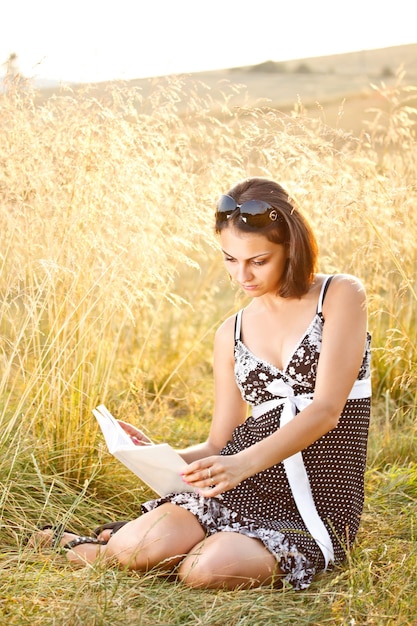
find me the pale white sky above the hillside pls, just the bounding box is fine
[0,0,417,82]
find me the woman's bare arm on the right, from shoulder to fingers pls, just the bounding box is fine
[185,275,367,496]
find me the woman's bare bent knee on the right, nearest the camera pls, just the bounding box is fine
[178,532,283,589]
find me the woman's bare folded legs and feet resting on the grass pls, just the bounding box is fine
[26,503,282,589]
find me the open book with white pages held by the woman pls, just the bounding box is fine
[93,404,194,496]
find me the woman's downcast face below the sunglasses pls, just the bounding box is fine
[220,226,288,298]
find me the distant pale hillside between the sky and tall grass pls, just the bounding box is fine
[23,43,417,132]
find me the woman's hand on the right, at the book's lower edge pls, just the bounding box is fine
[181,454,247,498]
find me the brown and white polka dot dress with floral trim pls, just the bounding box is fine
[142,276,370,589]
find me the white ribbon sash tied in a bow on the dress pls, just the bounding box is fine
[252,378,371,569]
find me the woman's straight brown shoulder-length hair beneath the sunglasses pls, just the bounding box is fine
[215,178,318,298]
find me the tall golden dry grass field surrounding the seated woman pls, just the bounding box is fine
[0,70,417,626]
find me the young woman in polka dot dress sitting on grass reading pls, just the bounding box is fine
[32,178,371,589]
